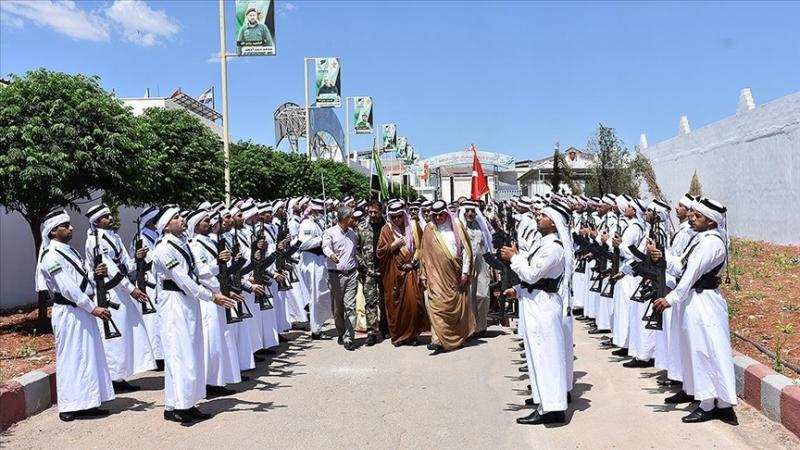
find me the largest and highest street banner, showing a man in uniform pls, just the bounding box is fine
[236,0,275,56]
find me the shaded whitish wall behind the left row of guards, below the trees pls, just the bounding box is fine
[0,201,138,309]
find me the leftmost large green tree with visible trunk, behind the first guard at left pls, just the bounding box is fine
[0,69,141,329]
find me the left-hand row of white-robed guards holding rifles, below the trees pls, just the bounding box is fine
[32,198,334,422]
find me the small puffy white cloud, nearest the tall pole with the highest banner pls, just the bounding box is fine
[105,0,179,47]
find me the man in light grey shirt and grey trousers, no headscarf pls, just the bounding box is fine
[322,206,358,350]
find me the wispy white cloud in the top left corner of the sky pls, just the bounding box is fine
[0,0,111,42]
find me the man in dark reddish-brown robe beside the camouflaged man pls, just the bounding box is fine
[375,202,430,346]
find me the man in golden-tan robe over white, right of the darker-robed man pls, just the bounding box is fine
[420,200,475,352]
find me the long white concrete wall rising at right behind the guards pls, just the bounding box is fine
[642,92,800,244]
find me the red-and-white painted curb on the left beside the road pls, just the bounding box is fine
[0,364,56,430]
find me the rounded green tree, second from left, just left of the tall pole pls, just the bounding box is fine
[134,108,225,206]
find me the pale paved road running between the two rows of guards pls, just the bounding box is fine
[0,324,800,449]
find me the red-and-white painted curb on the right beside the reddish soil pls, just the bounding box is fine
[733,350,800,436]
